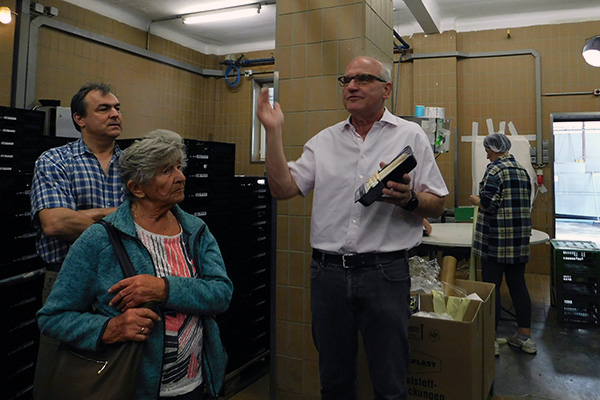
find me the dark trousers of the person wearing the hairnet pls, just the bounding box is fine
[481,259,531,329]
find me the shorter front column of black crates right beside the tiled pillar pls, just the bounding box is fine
[213,177,272,376]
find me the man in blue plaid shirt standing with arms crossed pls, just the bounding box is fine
[30,83,123,392]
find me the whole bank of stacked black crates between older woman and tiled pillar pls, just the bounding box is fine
[118,139,275,395]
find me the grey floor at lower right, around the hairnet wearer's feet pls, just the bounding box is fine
[494,275,600,400]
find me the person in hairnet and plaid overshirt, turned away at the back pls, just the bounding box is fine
[469,133,537,355]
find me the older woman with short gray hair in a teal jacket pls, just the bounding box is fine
[38,130,233,399]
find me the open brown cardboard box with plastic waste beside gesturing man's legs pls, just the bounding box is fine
[358,279,496,400]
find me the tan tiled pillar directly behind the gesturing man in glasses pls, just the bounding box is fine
[275,0,393,400]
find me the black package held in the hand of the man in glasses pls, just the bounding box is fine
[354,146,417,207]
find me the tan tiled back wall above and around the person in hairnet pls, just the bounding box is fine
[395,21,600,274]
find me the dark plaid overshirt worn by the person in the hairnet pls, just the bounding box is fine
[473,155,531,264]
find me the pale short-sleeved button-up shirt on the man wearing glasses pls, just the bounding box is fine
[288,109,448,254]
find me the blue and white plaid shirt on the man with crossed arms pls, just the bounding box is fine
[30,139,124,263]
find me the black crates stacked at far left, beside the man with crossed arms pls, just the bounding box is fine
[0,107,73,399]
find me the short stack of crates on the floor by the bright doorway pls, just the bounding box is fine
[550,240,600,326]
